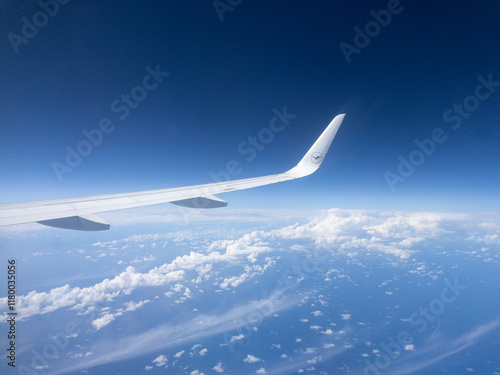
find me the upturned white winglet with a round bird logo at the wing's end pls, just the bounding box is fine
[286,113,345,178]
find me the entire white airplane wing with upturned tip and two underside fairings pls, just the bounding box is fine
[0,114,345,231]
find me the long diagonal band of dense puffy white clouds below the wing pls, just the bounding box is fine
[0,209,492,329]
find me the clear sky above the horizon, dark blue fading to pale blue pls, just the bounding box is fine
[0,0,500,211]
